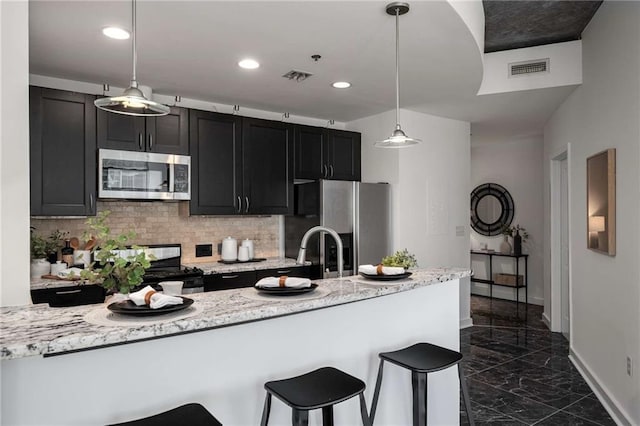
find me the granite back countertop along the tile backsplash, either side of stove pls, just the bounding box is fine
[31,257,298,290]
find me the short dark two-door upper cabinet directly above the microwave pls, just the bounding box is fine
[97,107,189,155]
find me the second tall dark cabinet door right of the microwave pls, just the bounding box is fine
[242,118,293,214]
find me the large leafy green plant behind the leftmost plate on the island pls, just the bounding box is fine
[80,210,152,294]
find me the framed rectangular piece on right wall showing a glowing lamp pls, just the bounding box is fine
[587,148,616,256]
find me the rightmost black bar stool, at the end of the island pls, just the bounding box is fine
[369,343,474,426]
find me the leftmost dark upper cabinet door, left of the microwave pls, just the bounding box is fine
[29,87,96,216]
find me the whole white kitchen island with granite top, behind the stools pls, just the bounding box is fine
[0,268,470,426]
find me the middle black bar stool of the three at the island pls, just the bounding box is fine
[260,367,371,426]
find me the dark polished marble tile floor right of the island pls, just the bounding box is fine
[460,296,615,426]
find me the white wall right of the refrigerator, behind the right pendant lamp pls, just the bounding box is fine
[346,110,471,326]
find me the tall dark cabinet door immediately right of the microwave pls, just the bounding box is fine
[189,110,243,215]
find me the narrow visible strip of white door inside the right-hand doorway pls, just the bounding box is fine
[560,158,570,340]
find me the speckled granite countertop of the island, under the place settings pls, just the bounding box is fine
[0,268,471,359]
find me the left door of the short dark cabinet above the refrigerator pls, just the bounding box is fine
[295,126,328,179]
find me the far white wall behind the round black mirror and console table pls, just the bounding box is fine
[469,136,546,305]
